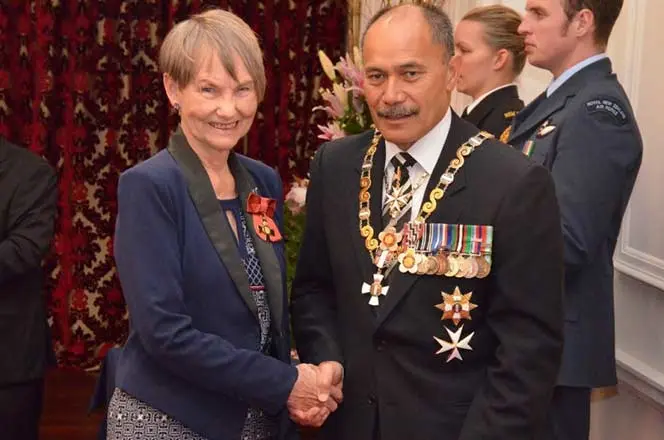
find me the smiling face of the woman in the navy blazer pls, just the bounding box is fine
[164,55,258,151]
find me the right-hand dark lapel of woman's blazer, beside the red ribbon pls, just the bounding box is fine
[228,153,284,330]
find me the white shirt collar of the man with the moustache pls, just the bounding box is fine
[385,108,452,175]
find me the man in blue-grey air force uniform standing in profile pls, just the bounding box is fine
[508,0,642,440]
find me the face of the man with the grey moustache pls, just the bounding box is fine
[362,7,455,149]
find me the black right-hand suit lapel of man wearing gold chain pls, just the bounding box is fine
[377,113,481,326]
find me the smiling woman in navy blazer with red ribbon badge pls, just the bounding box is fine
[107,10,334,440]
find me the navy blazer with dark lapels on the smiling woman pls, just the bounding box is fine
[115,131,297,440]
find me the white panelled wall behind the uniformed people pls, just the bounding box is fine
[365,0,664,440]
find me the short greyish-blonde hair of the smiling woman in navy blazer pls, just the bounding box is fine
[159,9,267,101]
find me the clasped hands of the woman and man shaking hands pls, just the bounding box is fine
[287,361,343,427]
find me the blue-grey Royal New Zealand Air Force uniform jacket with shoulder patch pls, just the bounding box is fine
[508,59,643,387]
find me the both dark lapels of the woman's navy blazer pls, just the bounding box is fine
[168,127,283,328]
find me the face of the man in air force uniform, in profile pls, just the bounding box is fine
[519,0,577,75]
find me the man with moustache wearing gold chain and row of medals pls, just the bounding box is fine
[291,5,562,440]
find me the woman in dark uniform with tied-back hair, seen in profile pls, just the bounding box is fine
[454,5,526,140]
